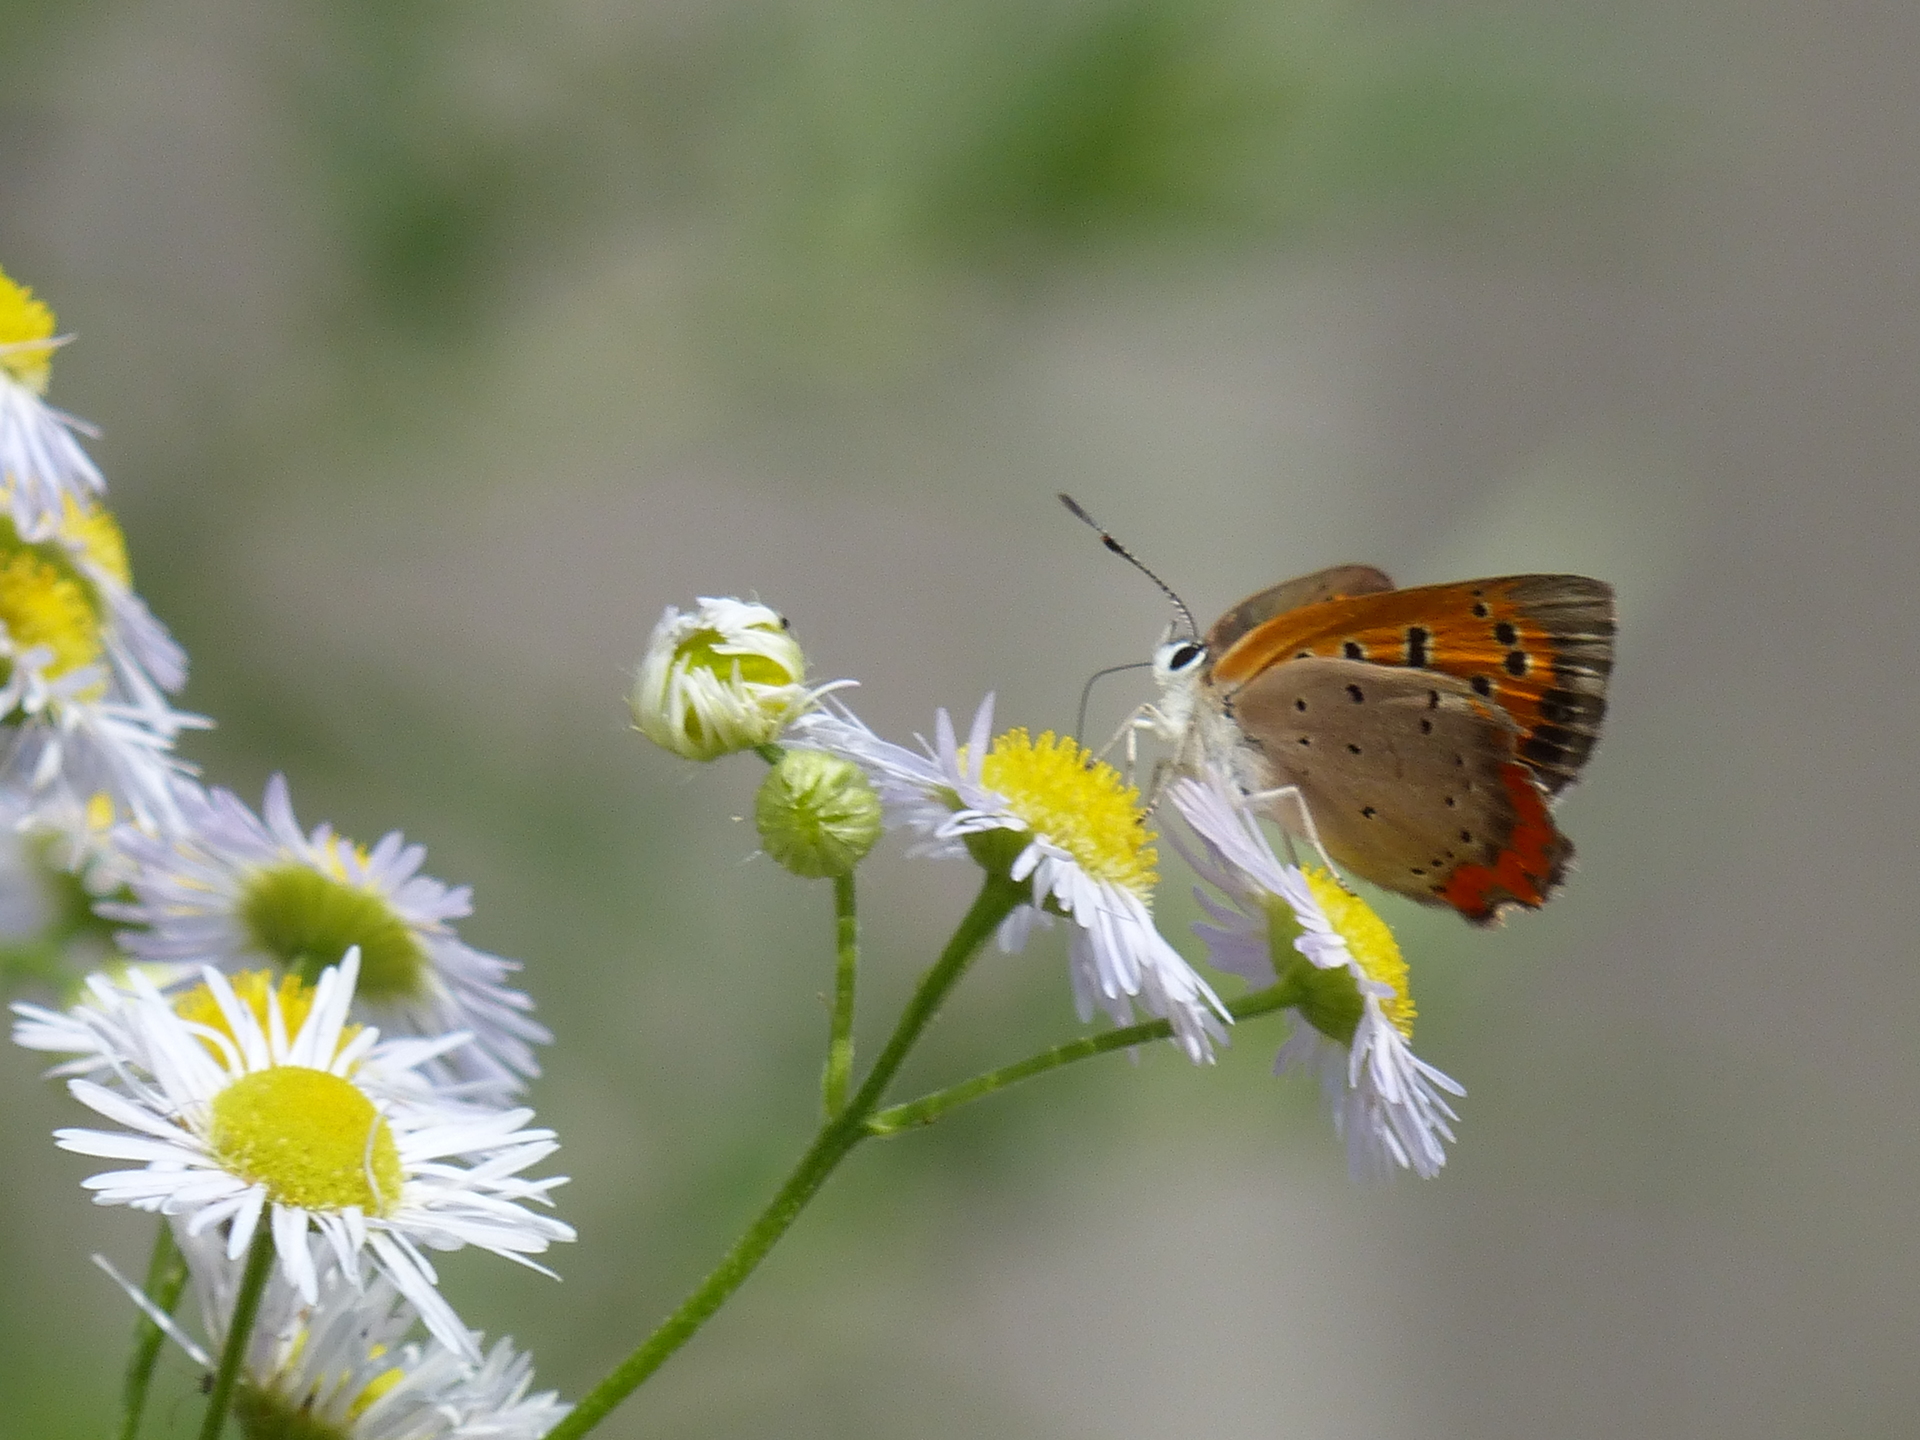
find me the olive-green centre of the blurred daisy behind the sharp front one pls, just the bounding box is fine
[238,856,432,1004]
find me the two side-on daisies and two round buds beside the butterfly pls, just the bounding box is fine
[632,599,1461,1177]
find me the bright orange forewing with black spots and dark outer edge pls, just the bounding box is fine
[1212,574,1613,797]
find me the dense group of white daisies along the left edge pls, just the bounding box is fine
[0,275,574,1440]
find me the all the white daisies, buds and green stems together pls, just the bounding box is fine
[0,263,1512,1440]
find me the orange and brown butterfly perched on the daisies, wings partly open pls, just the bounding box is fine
[1069,503,1615,924]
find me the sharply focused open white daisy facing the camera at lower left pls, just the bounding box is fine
[35,950,574,1359]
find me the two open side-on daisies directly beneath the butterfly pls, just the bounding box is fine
[789,695,1463,1179]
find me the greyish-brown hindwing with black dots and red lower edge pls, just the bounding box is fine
[1217,657,1572,924]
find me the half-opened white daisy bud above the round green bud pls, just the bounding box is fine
[628,595,851,760]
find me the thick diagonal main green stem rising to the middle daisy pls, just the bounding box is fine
[545,876,1027,1440]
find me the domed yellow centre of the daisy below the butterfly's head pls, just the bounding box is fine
[962,730,1160,900]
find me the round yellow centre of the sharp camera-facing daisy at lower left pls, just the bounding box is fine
[207,1066,401,1215]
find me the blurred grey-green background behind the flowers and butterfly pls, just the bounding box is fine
[0,0,1920,1440]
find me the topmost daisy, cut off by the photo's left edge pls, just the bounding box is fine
[0,273,108,518]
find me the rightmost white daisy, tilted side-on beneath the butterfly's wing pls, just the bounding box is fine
[1167,778,1465,1179]
